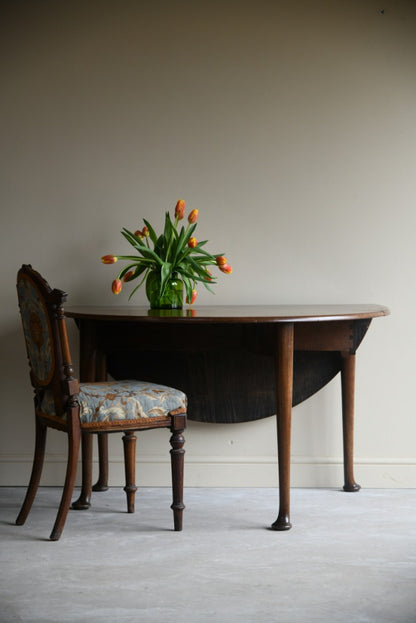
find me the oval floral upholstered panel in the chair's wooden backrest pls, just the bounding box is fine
[17,277,54,385]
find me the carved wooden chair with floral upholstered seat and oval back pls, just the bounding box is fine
[16,265,187,541]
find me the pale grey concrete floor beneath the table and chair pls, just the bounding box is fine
[0,488,416,623]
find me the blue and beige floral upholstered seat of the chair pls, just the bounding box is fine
[42,381,187,424]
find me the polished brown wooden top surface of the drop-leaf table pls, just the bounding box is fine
[65,304,390,324]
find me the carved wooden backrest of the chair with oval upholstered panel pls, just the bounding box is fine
[17,264,72,416]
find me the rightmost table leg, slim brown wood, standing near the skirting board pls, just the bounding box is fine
[341,352,361,491]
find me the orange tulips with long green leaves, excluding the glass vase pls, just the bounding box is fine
[101,199,232,304]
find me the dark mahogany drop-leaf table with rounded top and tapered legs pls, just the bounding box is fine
[66,304,389,530]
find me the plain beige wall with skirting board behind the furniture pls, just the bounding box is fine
[0,0,416,487]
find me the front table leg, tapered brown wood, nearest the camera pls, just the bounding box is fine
[271,323,294,530]
